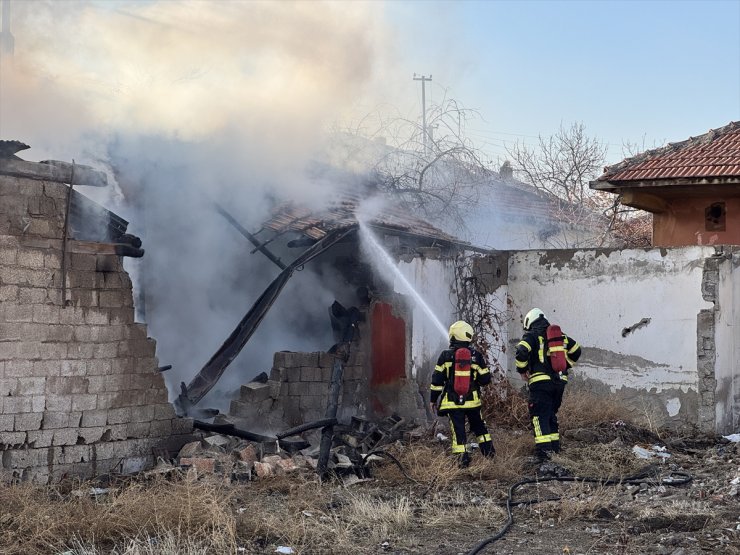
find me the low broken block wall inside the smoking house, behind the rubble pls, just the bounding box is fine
[229,350,368,432]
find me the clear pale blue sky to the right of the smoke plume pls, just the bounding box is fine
[386,0,740,162]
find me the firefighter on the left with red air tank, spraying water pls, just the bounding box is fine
[430,321,495,468]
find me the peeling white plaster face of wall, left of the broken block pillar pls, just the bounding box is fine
[507,247,716,430]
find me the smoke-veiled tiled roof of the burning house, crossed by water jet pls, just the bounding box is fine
[263,192,465,244]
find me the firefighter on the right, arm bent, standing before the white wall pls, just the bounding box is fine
[515,308,581,460]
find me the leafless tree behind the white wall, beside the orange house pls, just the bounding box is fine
[507,123,649,247]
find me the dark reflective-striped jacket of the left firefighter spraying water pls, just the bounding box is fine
[430,341,491,414]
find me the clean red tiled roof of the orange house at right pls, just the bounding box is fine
[594,121,740,184]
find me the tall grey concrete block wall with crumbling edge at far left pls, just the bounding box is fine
[0,175,192,483]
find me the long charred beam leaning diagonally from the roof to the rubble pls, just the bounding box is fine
[177,226,357,414]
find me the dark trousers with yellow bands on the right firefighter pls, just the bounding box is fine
[529,378,564,458]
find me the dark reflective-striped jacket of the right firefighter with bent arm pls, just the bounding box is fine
[515,318,581,385]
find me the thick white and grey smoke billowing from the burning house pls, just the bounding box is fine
[0,0,402,409]
